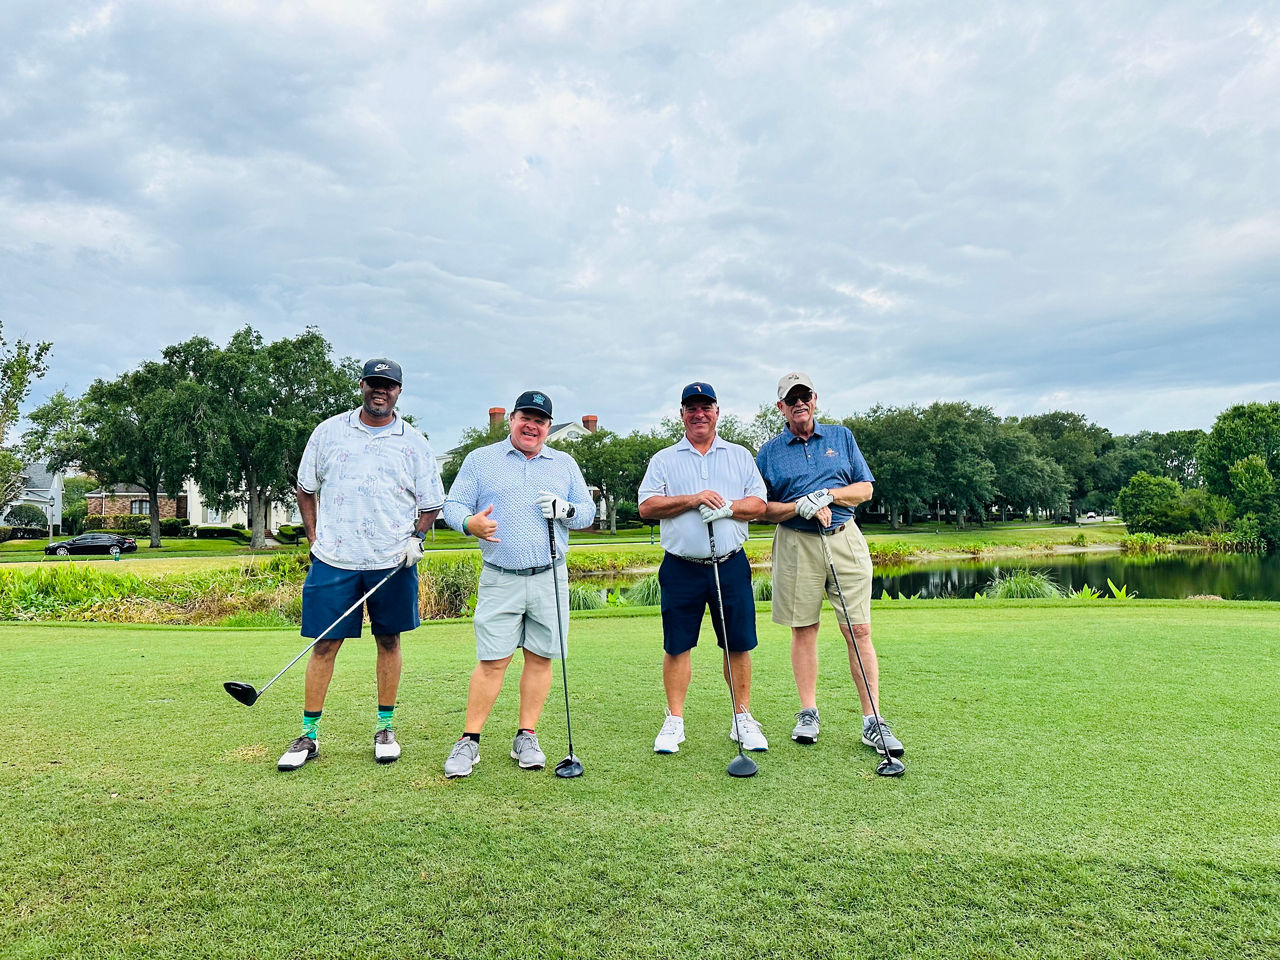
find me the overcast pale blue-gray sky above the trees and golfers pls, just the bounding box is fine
[0,0,1280,449]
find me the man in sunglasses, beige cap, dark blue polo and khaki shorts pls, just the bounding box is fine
[755,372,904,756]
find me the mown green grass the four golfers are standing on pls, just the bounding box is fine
[0,600,1280,960]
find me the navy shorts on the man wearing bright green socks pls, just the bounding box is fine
[302,557,422,640]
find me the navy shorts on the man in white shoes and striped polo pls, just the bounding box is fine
[658,550,756,657]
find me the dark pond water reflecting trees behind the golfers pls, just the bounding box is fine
[580,552,1280,600]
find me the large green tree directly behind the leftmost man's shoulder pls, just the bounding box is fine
[164,326,360,548]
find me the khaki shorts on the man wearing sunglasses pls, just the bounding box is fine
[773,524,872,627]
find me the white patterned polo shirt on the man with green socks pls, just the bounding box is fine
[298,408,444,570]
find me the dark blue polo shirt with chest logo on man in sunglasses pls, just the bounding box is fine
[755,424,876,532]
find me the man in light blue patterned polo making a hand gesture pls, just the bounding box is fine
[444,390,595,777]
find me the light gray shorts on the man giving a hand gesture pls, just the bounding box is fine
[475,563,568,660]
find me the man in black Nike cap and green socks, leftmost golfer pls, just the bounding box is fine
[276,358,444,771]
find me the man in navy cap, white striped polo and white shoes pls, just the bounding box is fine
[639,381,769,754]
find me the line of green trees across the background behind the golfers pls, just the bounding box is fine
[12,326,1280,547]
